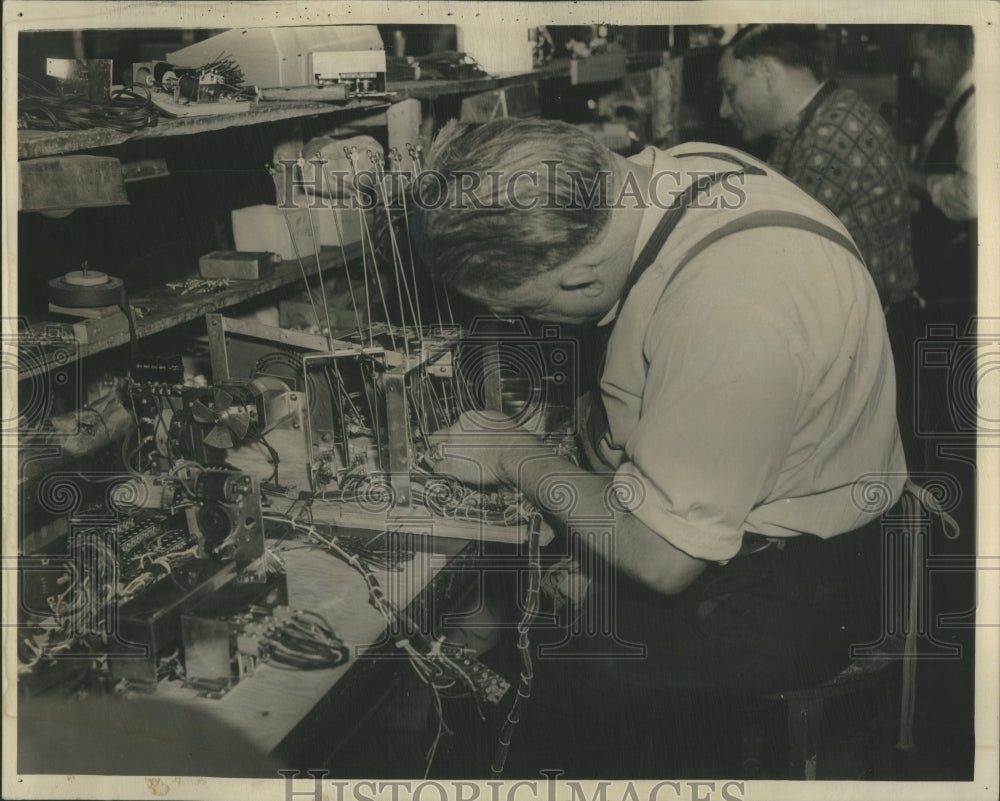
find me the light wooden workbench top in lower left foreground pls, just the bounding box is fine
[11,524,484,778]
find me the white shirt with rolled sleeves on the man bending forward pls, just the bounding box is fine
[598,144,906,561]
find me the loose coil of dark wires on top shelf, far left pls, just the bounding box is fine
[17,74,166,133]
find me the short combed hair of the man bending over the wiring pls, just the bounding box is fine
[414,119,613,290]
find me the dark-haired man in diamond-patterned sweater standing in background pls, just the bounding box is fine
[719,25,922,468]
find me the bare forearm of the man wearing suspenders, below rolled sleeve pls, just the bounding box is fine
[511,455,706,594]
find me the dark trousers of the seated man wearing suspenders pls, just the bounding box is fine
[505,520,881,778]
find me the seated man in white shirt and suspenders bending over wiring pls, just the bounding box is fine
[415,120,906,777]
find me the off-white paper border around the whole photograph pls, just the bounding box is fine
[2,0,1000,801]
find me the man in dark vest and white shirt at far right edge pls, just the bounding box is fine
[909,25,977,312]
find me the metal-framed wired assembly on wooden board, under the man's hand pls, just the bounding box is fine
[206,314,552,542]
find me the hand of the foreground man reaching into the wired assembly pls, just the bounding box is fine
[425,411,552,487]
